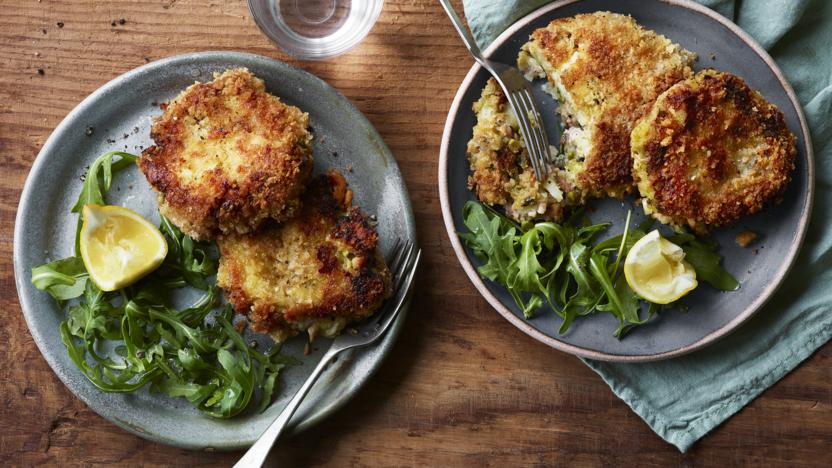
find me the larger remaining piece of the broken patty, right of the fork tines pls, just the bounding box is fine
[517,12,695,196]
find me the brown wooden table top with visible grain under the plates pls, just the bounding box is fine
[0,0,832,466]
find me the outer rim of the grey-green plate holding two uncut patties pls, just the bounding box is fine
[12,50,418,450]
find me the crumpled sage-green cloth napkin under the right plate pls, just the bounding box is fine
[463,0,832,452]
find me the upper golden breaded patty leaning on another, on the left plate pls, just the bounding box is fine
[138,68,312,240]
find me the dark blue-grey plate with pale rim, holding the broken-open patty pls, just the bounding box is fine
[439,0,814,361]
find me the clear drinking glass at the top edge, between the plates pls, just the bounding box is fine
[248,0,384,60]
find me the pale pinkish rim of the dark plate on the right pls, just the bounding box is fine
[438,0,815,363]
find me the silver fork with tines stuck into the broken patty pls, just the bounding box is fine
[439,0,550,182]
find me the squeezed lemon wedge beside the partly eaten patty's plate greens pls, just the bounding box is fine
[624,230,697,304]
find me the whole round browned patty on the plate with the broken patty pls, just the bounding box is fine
[632,70,797,232]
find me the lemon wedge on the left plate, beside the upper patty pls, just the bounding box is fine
[80,205,168,291]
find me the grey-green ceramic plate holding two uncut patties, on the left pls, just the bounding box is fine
[14,52,416,449]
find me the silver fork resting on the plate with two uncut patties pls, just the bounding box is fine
[234,240,422,468]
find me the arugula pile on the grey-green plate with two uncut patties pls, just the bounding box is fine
[32,151,297,418]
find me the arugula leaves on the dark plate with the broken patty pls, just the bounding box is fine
[459,201,739,339]
